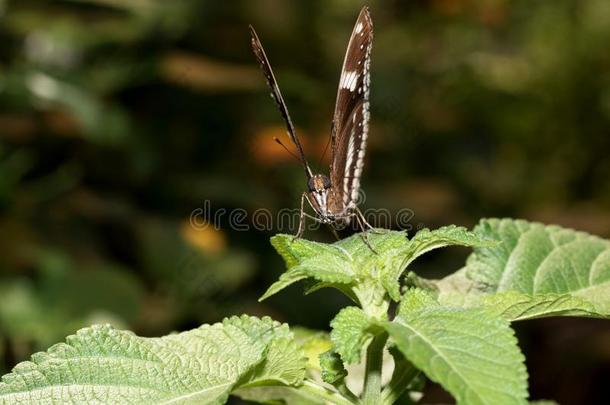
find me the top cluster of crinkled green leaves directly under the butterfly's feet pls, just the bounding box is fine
[261,226,493,304]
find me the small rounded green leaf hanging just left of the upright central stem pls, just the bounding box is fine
[330,307,372,364]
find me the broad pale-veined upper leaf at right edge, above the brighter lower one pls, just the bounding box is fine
[466,219,610,315]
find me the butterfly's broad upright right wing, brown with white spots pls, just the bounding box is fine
[330,7,373,211]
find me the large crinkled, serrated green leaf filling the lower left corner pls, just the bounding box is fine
[0,316,305,404]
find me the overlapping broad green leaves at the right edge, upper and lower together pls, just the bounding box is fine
[438,219,610,320]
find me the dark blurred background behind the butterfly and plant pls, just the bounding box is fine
[0,0,610,404]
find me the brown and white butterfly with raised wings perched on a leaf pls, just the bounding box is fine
[250,7,373,238]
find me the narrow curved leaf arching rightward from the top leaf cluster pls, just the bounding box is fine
[381,225,496,301]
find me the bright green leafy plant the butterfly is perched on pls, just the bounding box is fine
[0,219,610,405]
